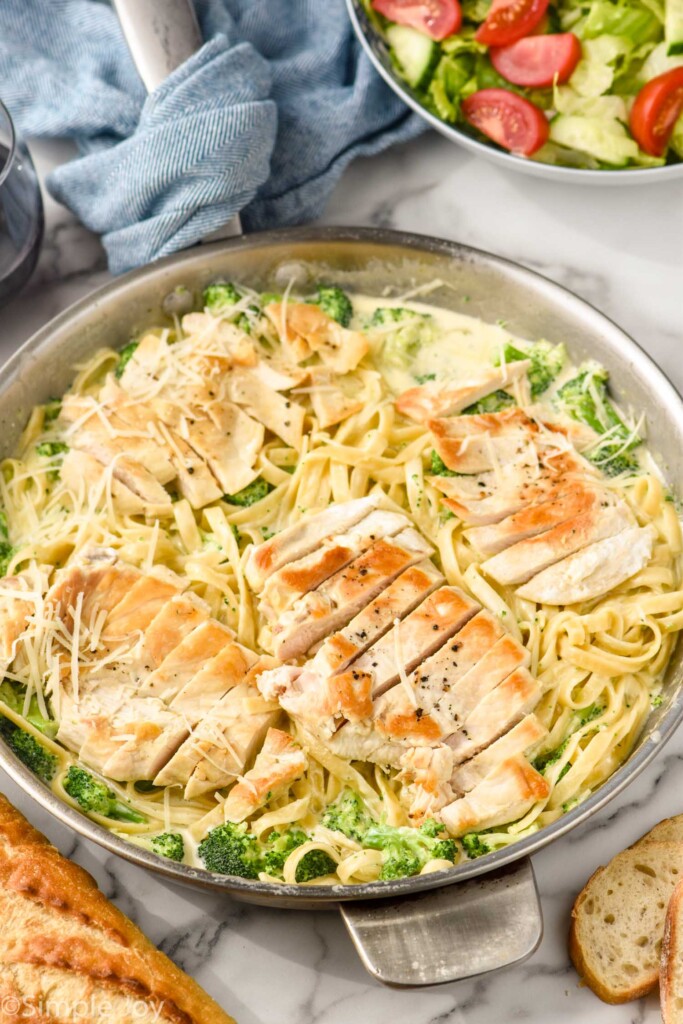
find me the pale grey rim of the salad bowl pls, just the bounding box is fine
[346,0,683,185]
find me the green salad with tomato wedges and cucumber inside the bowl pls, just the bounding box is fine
[364,0,683,170]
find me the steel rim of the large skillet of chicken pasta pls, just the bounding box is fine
[0,226,683,909]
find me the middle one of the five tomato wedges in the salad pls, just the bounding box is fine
[488,32,581,89]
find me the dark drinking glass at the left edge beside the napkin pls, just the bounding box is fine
[0,103,43,305]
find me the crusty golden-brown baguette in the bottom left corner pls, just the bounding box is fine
[0,795,234,1024]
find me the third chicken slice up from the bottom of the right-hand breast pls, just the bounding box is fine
[464,481,606,555]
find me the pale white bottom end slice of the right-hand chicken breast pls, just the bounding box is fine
[517,526,656,604]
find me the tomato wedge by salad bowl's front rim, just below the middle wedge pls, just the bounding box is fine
[461,89,549,157]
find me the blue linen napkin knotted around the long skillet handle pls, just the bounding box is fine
[0,0,424,273]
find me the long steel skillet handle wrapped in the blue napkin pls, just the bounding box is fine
[114,0,242,242]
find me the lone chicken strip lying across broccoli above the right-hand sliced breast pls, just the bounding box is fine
[396,359,530,423]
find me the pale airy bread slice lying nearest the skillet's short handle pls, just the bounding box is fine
[569,842,683,1002]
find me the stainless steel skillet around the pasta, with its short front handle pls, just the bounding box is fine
[0,228,683,985]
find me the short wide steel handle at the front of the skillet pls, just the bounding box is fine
[340,858,543,987]
